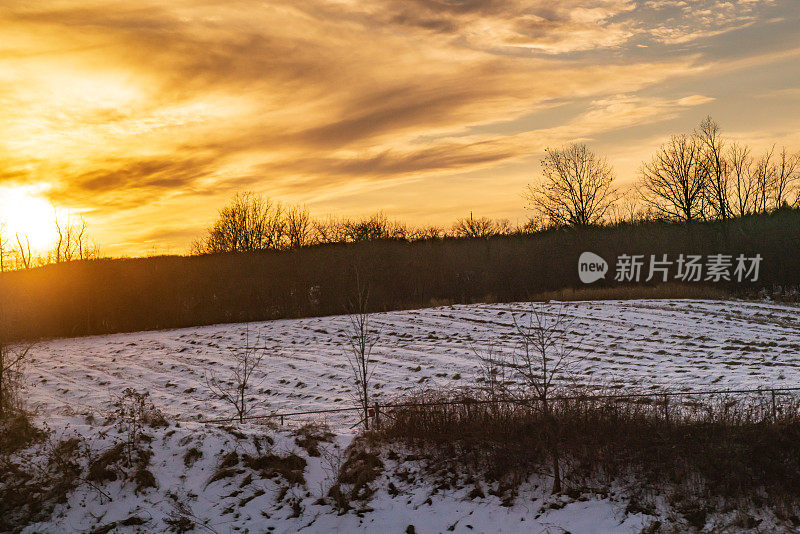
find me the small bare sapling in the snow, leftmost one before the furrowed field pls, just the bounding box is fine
[206,328,267,422]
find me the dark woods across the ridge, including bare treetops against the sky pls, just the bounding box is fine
[0,118,800,339]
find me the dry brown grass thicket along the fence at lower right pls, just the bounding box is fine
[377,392,800,523]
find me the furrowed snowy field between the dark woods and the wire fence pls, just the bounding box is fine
[29,300,800,424]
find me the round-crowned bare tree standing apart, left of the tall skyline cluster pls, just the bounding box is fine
[525,144,617,226]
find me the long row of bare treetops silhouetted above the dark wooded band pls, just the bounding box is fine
[191,117,800,254]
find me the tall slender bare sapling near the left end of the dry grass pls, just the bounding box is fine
[345,275,378,430]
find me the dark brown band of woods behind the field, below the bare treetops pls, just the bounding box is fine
[0,208,800,338]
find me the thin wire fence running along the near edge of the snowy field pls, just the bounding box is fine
[181,387,800,426]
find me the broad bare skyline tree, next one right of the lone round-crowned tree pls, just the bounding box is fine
[640,134,708,222]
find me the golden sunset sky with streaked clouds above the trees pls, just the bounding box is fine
[0,0,800,256]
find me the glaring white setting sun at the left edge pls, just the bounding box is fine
[0,186,58,253]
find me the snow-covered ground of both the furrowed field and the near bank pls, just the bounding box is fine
[10,300,800,533]
